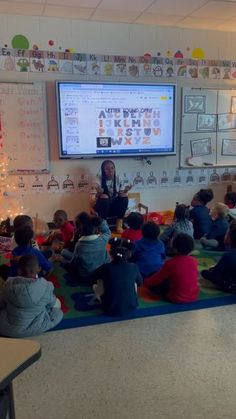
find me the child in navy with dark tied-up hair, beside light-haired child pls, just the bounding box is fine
[190,189,214,239]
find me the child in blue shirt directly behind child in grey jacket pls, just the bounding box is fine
[10,226,52,276]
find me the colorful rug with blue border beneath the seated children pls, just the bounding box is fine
[47,250,236,330]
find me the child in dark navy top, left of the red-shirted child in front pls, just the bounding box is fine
[93,239,142,316]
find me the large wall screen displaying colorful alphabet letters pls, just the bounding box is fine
[57,82,175,157]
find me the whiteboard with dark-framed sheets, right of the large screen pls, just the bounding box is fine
[180,88,236,167]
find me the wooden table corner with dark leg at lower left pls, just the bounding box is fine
[0,338,41,419]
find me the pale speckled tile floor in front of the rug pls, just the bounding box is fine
[14,306,236,419]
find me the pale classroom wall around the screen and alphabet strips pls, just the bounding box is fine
[0,15,236,221]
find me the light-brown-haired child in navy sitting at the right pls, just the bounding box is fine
[200,202,229,250]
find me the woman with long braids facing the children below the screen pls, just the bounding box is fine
[93,160,132,233]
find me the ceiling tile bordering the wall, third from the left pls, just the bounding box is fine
[91,9,139,23]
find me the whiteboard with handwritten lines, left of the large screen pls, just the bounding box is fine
[0,82,49,174]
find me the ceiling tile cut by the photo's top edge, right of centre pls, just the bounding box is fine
[146,0,207,16]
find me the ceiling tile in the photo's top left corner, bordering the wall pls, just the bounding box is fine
[0,1,44,16]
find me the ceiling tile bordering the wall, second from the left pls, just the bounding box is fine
[44,5,94,19]
